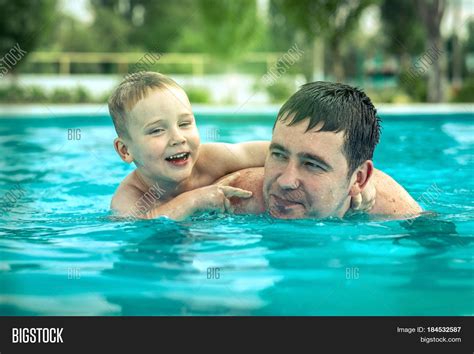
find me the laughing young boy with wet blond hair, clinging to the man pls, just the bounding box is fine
[109,72,374,220]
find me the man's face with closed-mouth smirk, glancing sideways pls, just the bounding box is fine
[263,117,355,219]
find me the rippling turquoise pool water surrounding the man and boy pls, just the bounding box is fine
[0,112,474,315]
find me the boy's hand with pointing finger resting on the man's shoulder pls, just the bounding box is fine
[190,173,252,213]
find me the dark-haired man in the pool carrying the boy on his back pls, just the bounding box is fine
[226,81,422,219]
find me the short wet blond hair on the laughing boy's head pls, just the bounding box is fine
[108,71,180,137]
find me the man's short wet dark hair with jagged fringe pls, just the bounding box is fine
[273,81,380,176]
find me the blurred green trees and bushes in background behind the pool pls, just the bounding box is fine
[0,0,474,102]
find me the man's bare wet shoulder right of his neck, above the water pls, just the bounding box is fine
[370,169,422,217]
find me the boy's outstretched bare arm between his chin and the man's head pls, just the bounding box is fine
[203,141,270,175]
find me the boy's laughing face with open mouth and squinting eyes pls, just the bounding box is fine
[123,87,200,183]
